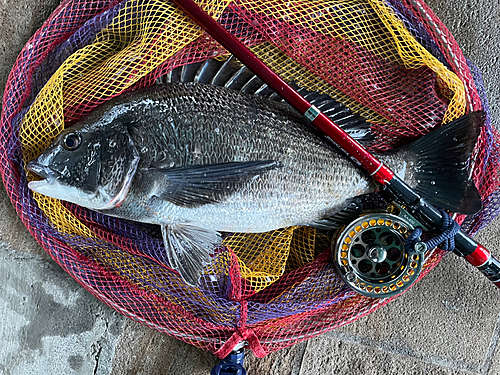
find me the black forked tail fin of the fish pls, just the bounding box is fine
[409,112,484,215]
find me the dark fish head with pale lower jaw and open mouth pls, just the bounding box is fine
[28,123,139,210]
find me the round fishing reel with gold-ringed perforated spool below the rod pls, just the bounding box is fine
[332,212,425,298]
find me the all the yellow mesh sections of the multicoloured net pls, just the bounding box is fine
[20,0,465,290]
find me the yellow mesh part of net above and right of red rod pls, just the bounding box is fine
[243,0,465,124]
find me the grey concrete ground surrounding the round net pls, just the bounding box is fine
[0,0,500,375]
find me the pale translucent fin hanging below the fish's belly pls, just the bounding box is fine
[161,223,221,286]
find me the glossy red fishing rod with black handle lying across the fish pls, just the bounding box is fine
[173,0,500,288]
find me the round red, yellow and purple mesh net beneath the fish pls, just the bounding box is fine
[0,0,500,357]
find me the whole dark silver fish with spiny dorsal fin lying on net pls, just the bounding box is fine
[27,57,483,286]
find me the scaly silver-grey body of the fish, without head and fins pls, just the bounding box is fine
[74,84,384,232]
